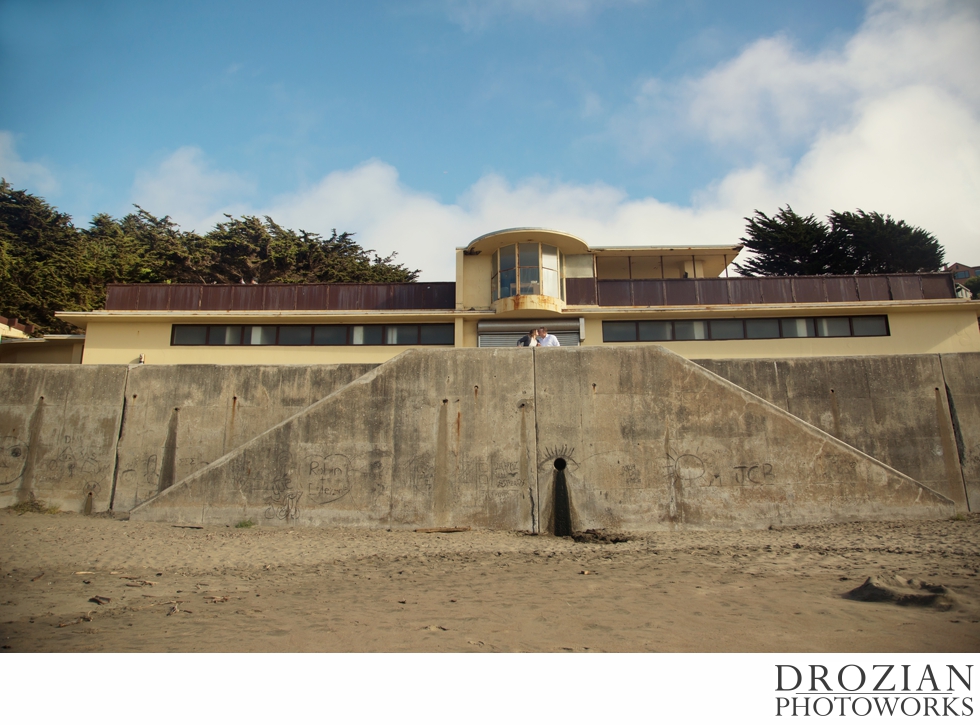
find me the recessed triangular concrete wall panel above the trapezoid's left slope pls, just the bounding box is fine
[113,365,376,511]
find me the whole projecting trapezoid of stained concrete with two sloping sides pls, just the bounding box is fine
[131,347,954,532]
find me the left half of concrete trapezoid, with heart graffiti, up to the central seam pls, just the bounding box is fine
[132,349,537,530]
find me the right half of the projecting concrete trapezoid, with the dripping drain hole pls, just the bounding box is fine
[534,347,953,531]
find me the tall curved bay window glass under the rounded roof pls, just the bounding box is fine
[490,242,565,302]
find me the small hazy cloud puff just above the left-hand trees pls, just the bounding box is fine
[132,146,254,229]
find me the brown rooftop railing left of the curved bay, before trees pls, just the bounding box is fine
[106,282,456,312]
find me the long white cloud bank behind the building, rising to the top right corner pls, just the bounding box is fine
[137,0,980,280]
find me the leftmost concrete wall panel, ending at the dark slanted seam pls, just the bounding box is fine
[0,365,127,512]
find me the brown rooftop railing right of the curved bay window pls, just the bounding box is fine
[565,272,956,307]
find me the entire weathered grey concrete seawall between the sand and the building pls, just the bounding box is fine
[0,347,980,531]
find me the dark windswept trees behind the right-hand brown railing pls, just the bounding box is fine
[735,205,944,277]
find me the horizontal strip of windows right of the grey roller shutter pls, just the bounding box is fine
[602,315,889,342]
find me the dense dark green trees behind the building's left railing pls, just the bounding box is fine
[0,179,419,334]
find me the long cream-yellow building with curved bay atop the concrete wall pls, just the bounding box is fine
[58,228,980,365]
